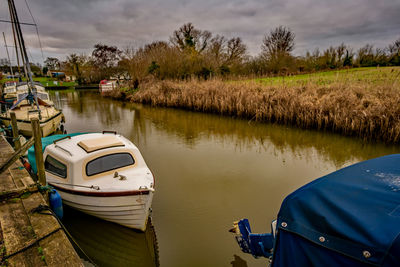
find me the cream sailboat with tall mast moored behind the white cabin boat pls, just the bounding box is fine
[0,0,64,136]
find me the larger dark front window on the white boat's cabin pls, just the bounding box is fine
[86,153,135,176]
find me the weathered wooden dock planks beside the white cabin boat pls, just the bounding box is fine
[0,136,83,266]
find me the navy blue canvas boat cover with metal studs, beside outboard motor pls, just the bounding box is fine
[272,154,400,267]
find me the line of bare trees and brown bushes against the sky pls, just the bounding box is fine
[40,23,400,87]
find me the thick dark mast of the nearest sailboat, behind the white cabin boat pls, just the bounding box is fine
[8,0,42,119]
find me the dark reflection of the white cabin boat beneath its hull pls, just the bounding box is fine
[63,207,160,267]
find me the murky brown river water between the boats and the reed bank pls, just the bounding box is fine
[51,91,400,267]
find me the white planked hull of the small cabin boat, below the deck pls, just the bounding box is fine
[49,183,153,231]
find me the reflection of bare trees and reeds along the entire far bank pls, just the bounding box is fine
[54,91,399,168]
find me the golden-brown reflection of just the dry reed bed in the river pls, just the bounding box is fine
[128,105,399,168]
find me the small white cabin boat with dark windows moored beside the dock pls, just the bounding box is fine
[32,132,154,231]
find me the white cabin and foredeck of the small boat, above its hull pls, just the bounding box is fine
[40,132,154,190]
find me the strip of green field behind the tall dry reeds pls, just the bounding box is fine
[246,67,400,86]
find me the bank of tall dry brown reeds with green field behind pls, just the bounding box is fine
[108,67,400,143]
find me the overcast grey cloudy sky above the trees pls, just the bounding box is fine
[0,0,400,62]
